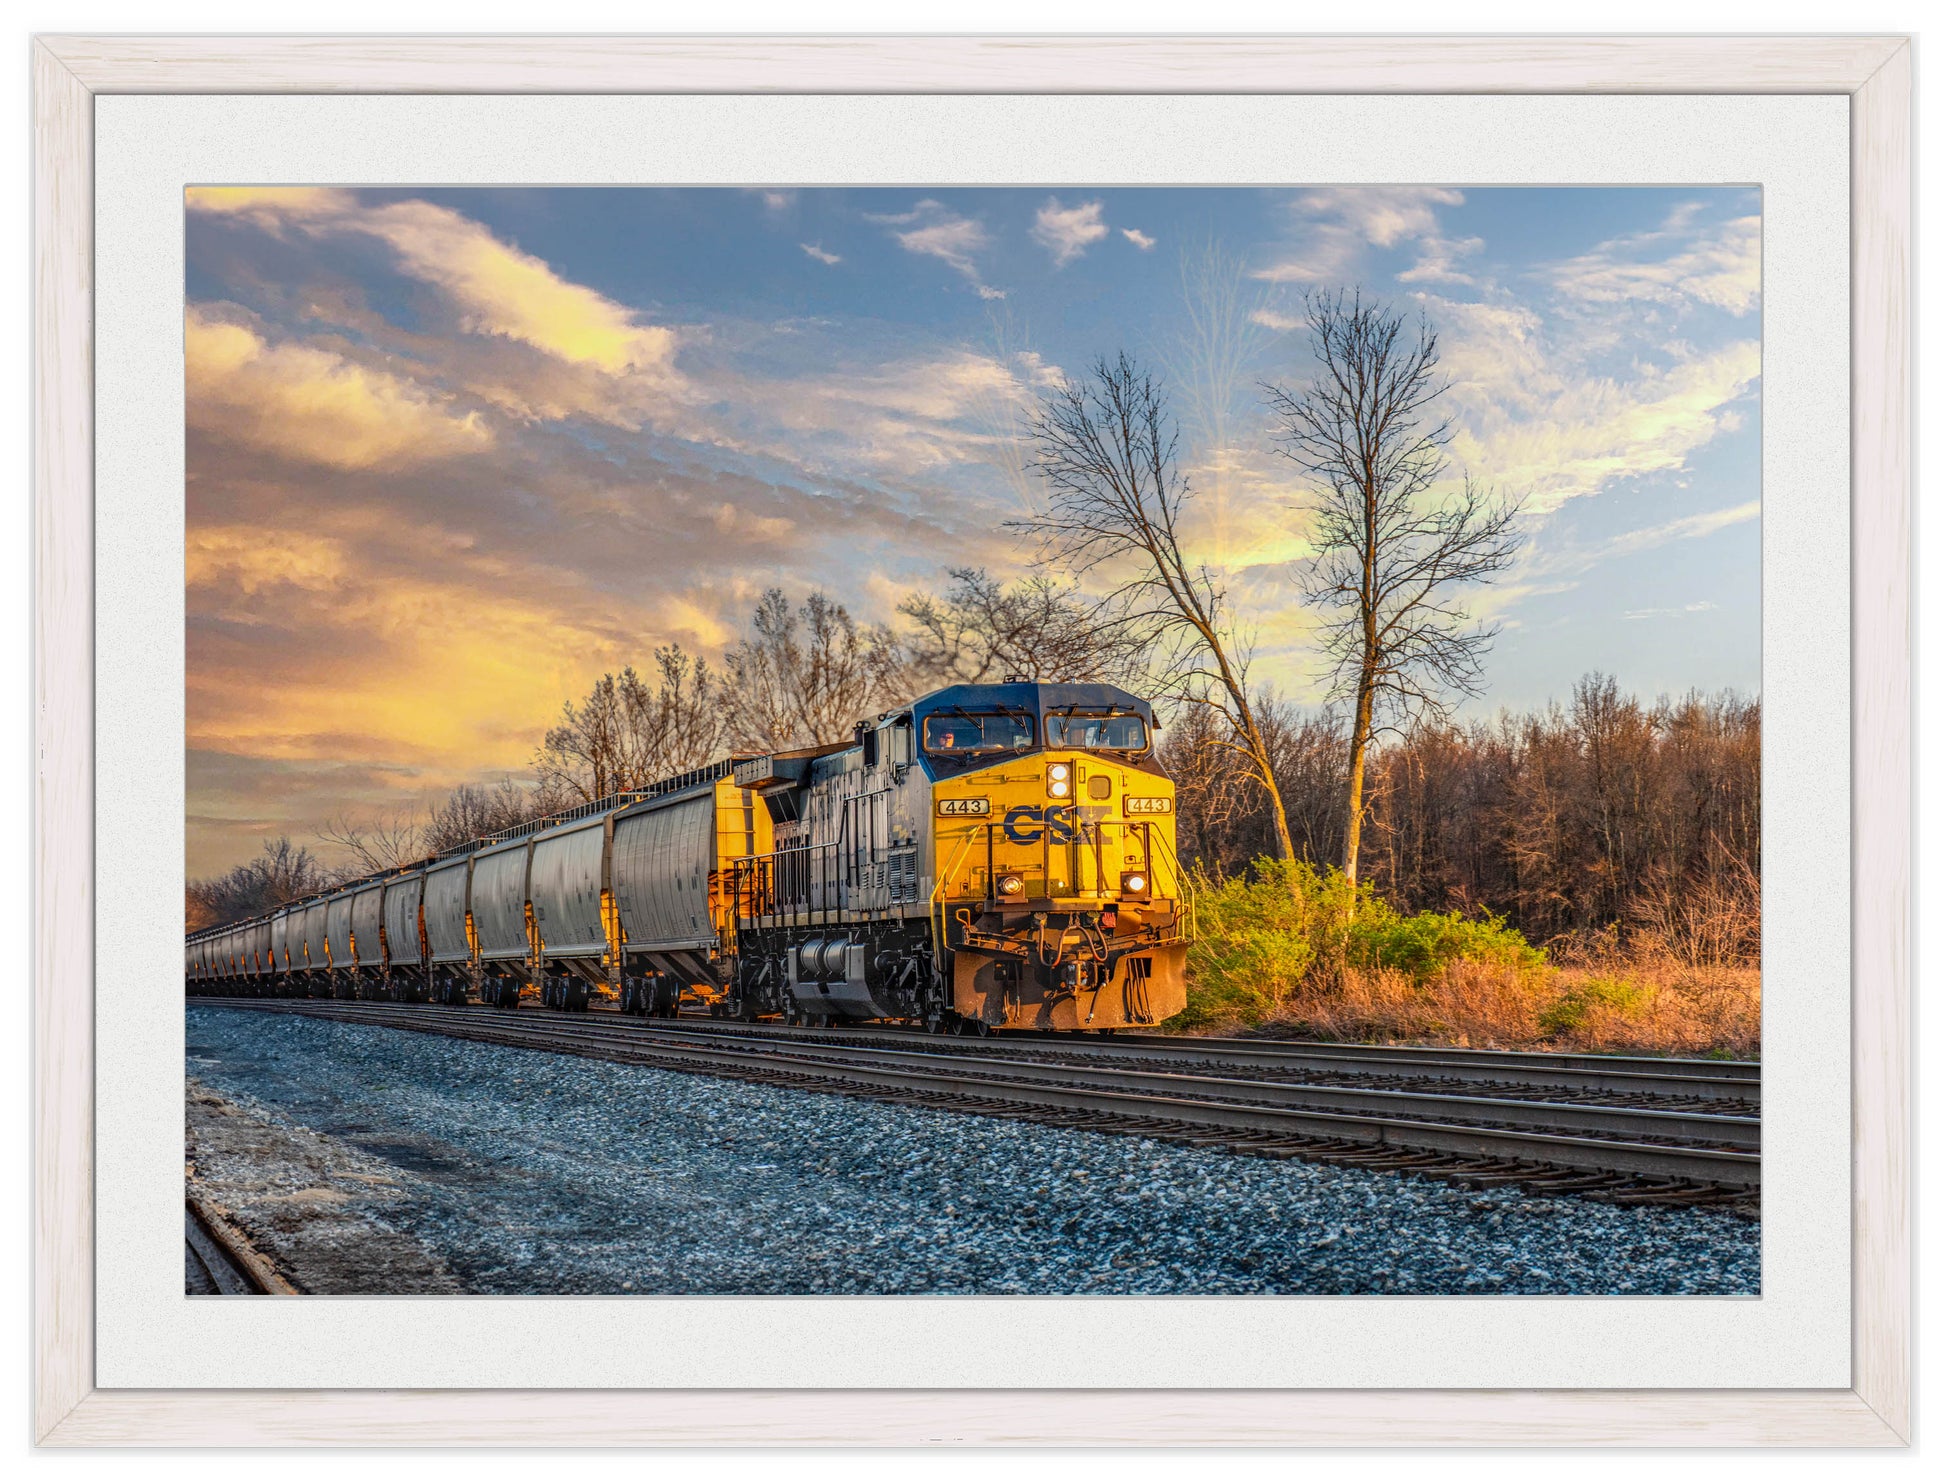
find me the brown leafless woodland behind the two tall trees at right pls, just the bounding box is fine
[1162,673,1763,965]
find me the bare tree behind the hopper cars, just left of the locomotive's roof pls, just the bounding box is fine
[722,588,905,747]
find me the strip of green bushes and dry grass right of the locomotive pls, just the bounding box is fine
[1168,858,1759,1055]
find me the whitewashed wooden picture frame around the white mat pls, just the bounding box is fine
[33,37,1913,1446]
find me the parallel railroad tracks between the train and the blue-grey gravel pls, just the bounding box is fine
[197,998,1761,1211]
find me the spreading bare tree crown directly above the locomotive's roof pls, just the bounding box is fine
[899,566,1140,685]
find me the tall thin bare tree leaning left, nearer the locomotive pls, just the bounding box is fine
[1012,352,1296,860]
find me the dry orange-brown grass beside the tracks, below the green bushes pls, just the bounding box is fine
[1210,948,1761,1059]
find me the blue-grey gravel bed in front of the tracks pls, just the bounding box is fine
[189,1006,1759,1294]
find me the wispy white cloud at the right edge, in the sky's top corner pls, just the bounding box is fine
[1541,206,1763,315]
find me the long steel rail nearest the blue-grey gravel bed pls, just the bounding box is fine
[193,998,1761,1189]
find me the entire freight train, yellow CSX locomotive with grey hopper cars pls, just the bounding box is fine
[183,679,1195,1035]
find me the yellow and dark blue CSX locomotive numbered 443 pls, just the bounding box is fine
[732,681,1189,1033]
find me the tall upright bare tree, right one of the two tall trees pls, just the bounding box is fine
[1265,294,1520,880]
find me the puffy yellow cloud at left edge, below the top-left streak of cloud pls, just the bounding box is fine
[183,304,494,469]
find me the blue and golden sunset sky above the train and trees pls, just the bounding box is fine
[185,185,1761,876]
